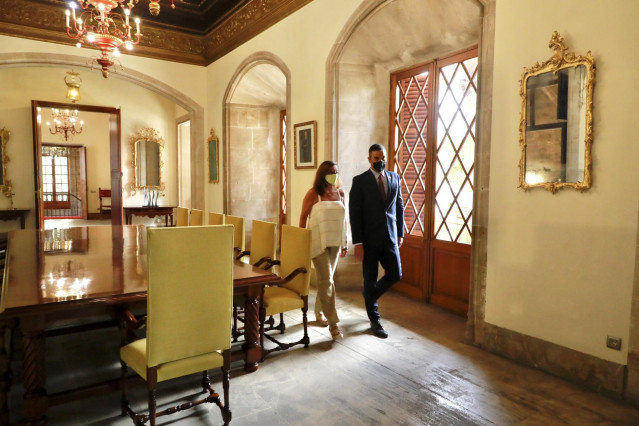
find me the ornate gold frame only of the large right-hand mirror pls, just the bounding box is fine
[519,31,595,194]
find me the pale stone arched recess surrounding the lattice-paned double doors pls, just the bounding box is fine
[326,0,495,330]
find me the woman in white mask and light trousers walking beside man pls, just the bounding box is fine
[300,161,348,340]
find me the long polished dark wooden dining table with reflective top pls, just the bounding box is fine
[0,225,280,424]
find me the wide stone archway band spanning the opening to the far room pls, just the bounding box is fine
[0,52,204,209]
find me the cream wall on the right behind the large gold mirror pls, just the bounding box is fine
[485,0,639,364]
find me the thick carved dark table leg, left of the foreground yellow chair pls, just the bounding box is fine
[20,316,47,425]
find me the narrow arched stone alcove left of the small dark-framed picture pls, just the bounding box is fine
[224,52,290,246]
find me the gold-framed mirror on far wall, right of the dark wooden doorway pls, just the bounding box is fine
[126,127,165,196]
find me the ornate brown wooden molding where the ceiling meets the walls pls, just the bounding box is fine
[0,0,313,65]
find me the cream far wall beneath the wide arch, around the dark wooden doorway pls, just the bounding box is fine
[0,67,177,231]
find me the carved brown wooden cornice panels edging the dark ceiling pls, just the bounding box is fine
[0,0,312,65]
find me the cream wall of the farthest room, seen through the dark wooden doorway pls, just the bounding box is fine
[39,110,111,213]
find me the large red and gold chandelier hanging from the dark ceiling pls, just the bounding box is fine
[65,0,142,78]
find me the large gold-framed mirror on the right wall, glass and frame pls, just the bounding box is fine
[519,31,595,194]
